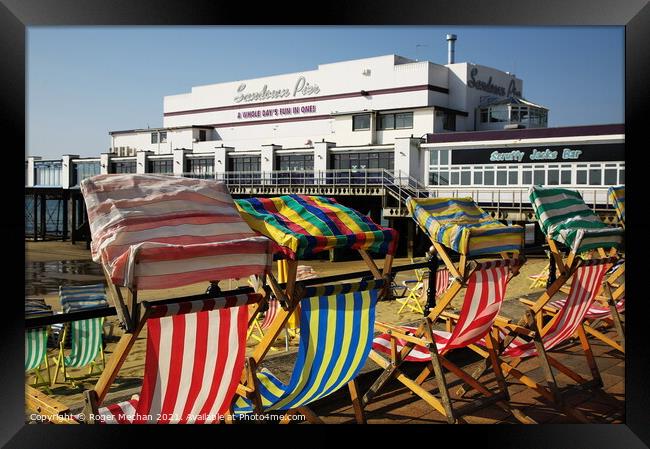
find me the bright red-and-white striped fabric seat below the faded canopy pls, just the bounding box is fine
[91,293,261,424]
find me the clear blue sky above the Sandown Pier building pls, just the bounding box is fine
[26,26,625,158]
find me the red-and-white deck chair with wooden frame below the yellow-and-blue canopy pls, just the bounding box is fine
[363,258,532,423]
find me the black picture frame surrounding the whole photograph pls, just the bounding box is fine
[6,0,650,449]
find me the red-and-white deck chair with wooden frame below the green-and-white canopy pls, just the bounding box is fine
[480,257,616,422]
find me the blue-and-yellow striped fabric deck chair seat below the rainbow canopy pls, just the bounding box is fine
[234,280,384,422]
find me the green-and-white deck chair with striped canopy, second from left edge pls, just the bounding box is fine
[52,284,108,385]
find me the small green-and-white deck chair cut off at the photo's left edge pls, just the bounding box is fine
[25,298,52,392]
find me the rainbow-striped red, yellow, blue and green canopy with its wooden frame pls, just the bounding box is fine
[237,195,398,421]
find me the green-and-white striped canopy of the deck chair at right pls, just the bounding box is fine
[529,186,625,266]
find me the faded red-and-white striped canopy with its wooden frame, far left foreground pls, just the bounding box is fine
[24,174,275,424]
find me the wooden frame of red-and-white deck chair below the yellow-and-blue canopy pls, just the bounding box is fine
[362,257,534,424]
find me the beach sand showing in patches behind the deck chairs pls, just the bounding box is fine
[25,242,547,410]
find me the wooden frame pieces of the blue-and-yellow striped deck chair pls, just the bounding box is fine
[237,250,394,424]
